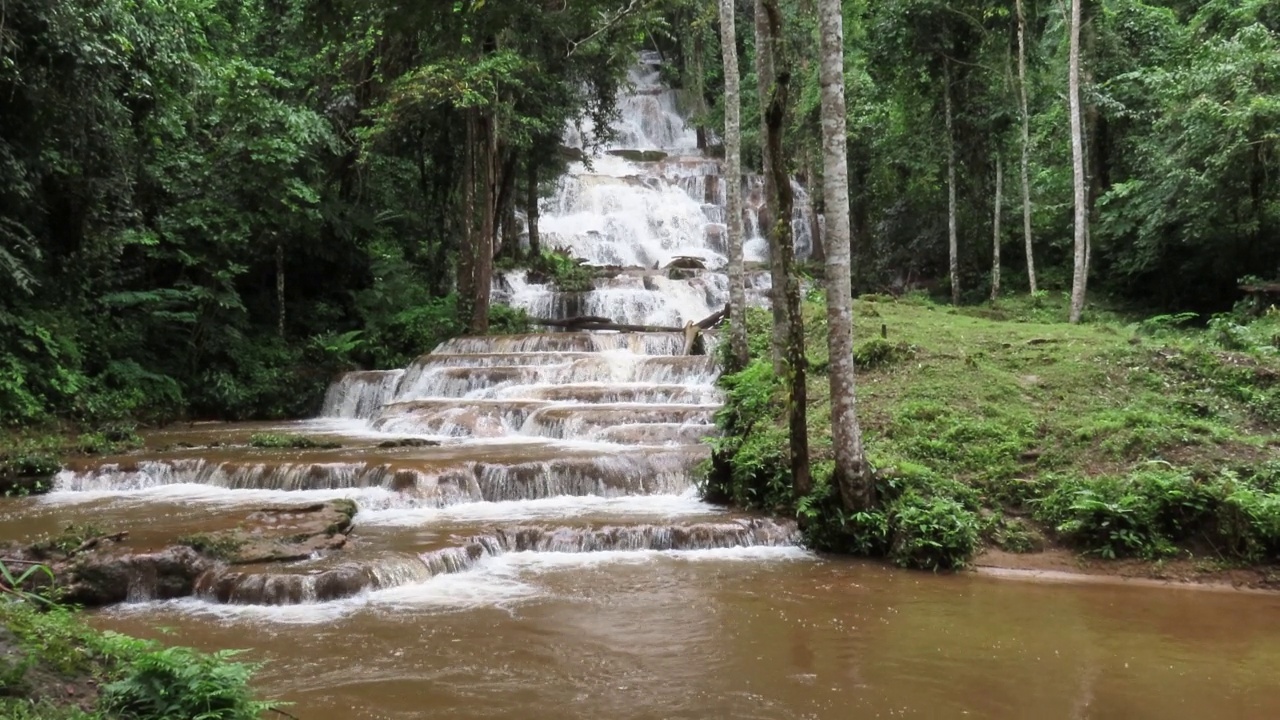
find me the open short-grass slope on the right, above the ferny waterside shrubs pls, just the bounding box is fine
[809,294,1280,489]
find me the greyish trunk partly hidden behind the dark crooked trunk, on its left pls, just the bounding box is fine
[755,0,791,375]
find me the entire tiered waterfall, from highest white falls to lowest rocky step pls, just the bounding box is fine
[24,53,809,606]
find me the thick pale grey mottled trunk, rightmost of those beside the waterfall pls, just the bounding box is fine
[818,0,876,511]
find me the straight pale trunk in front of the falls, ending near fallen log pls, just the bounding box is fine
[719,0,750,369]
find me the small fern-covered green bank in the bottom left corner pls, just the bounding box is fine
[0,565,271,720]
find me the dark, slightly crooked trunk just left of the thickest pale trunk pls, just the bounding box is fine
[764,0,813,498]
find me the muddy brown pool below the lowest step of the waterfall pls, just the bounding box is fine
[95,552,1280,720]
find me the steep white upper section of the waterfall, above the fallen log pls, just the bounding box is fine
[494,54,814,327]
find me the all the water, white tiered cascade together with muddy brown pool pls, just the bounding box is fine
[0,53,1280,720]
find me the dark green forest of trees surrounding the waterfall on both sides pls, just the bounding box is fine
[0,0,1280,427]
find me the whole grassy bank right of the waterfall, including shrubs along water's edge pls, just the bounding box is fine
[708,288,1280,569]
